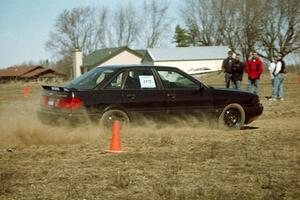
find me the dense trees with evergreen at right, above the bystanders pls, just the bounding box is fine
[174,0,300,60]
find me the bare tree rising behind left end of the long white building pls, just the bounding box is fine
[141,0,171,48]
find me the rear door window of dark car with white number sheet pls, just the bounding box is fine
[124,69,157,90]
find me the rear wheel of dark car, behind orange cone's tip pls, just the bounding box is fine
[100,109,129,128]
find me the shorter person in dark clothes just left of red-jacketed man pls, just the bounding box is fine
[232,53,244,90]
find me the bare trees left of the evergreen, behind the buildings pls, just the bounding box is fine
[46,0,171,60]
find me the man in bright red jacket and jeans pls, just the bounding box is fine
[246,51,263,94]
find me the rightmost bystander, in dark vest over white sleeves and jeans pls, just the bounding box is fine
[272,54,286,101]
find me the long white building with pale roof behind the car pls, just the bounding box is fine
[141,46,228,74]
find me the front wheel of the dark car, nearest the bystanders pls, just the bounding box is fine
[218,103,245,129]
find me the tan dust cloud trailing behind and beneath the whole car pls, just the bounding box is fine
[0,99,216,148]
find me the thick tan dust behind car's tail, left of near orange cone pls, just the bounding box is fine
[0,100,100,147]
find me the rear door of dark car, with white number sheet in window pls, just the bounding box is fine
[122,68,166,116]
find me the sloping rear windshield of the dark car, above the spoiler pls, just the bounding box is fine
[64,67,115,90]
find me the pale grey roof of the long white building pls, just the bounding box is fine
[144,46,228,61]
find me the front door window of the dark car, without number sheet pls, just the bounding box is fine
[157,70,199,89]
